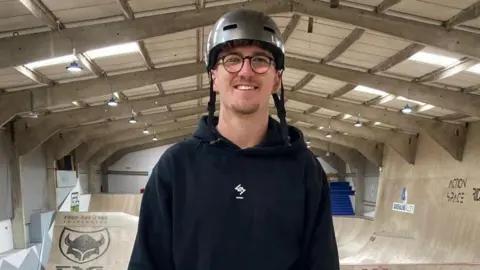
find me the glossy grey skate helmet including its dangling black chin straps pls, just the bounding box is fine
[204,9,290,146]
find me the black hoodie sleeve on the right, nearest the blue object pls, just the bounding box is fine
[305,157,340,270]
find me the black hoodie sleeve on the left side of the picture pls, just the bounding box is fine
[128,155,174,270]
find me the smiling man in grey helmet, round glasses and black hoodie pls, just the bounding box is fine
[128,10,340,270]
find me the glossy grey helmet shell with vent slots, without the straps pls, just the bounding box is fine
[204,9,285,70]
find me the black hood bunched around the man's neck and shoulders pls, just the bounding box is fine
[193,116,307,155]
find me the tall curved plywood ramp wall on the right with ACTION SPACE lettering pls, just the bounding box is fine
[341,123,480,270]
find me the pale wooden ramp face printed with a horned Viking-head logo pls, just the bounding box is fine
[45,212,138,270]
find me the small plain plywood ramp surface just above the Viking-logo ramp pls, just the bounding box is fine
[88,194,143,216]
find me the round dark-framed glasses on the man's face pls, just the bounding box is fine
[220,54,273,74]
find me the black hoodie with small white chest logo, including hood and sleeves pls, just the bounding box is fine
[128,117,340,270]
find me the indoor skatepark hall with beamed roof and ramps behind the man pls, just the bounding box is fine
[0,0,480,270]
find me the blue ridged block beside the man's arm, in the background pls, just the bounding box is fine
[330,182,355,216]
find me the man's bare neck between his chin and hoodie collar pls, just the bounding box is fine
[217,105,268,149]
